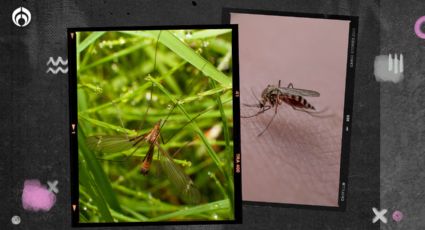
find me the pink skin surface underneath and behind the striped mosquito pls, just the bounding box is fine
[231,13,349,206]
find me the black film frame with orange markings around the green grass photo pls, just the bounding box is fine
[67,25,242,227]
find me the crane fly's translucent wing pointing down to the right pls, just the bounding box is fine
[157,145,201,204]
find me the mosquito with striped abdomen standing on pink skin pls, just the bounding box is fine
[241,80,320,136]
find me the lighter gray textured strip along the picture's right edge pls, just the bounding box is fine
[379,0,425,229]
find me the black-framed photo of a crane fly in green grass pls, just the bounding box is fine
[68,25,241,226]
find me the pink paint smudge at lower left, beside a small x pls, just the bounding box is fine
[22,180,56,212]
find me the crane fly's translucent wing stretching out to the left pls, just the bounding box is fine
[86,135,139,153]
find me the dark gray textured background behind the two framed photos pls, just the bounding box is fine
[0,0,425,230]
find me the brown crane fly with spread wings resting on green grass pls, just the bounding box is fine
[86,120,200,204]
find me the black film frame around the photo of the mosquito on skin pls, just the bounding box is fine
[222,8,358,211]
